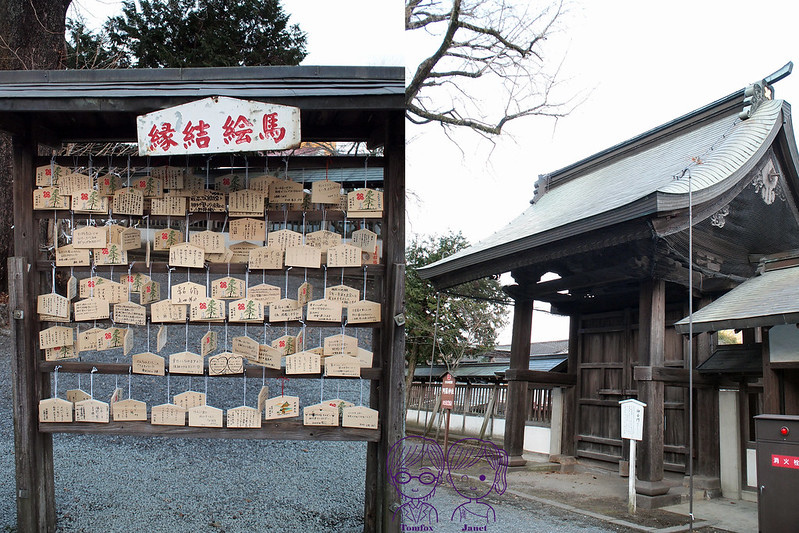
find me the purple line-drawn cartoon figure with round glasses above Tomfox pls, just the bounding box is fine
[387,436,444,524]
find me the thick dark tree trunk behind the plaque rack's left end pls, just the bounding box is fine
[0,0,72,291]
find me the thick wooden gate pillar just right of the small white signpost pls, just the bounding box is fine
[630,280,669,502]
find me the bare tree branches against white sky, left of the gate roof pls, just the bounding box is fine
[405,0,573,136]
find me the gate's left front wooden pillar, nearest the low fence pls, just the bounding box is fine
[505,298,533,466]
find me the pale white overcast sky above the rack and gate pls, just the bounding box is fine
[74,0,799,342]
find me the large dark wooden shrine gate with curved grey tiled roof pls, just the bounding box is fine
[419,64,799,507]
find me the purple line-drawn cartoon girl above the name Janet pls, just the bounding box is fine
[447,438,508,524]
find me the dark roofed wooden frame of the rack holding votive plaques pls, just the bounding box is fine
[0,67,405,532]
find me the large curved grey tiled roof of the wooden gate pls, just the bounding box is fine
[419,94,789,285]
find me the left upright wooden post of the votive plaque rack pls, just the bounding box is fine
[8,127,56,533]
